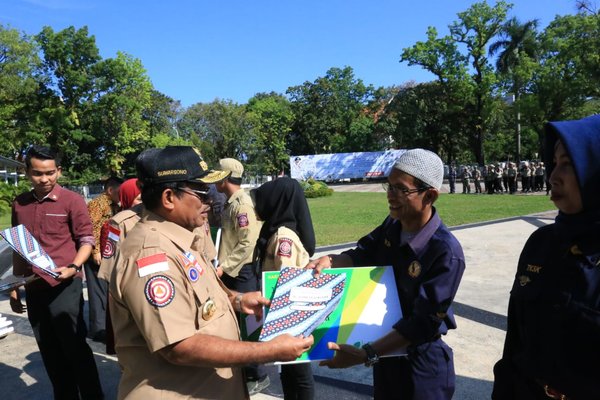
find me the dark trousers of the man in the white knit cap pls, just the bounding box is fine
[373,339,456,400]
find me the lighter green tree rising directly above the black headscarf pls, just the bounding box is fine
[247,92,294,176]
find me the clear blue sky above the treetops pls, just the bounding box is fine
[0,0,576,106]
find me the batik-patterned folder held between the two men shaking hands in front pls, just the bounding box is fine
[259,267,346,341]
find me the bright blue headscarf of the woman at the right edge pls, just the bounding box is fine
[544,115,600,242]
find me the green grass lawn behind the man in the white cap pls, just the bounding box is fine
[308,192,555,246]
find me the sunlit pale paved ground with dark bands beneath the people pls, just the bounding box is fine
[0,212,555,400]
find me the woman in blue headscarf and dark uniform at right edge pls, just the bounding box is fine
[492,115,600,400]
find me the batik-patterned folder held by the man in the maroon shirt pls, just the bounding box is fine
[0,225,60,286]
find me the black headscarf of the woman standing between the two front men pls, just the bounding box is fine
[251,177,315,258]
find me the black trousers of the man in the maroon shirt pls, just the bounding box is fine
[26,278,103,400]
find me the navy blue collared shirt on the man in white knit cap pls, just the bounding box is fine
[344,208,465,345]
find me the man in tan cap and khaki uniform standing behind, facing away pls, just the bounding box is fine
[215,158,270,395]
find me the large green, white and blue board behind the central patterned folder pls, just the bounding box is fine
[258,267,405,362]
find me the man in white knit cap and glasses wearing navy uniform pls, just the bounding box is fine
[307,149,465,400]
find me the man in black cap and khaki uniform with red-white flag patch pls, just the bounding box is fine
[110,146,313,400]
